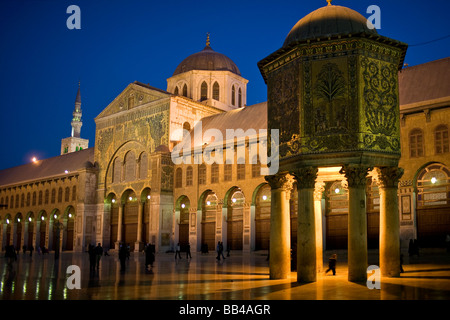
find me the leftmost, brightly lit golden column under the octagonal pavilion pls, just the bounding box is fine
[265,173,294,279]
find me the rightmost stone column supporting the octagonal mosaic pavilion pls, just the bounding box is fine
[377,167,403,277]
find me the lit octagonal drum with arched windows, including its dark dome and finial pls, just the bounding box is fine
[167,34,248,111]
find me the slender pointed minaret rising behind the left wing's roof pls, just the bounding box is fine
[61,82,89,154]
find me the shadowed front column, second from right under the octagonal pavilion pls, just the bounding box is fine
[340,164,371,282]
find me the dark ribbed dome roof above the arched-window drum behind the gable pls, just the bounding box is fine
[173,44,241,76]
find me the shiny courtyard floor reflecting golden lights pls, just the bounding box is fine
[0,252,450,300]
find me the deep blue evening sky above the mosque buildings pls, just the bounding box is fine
[0,0,450,169]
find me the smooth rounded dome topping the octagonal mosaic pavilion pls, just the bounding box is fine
[283,5,378,47]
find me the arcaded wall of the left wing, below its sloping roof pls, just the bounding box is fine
[0,168,97,251]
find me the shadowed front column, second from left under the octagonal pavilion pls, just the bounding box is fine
[293,167,318,282]
